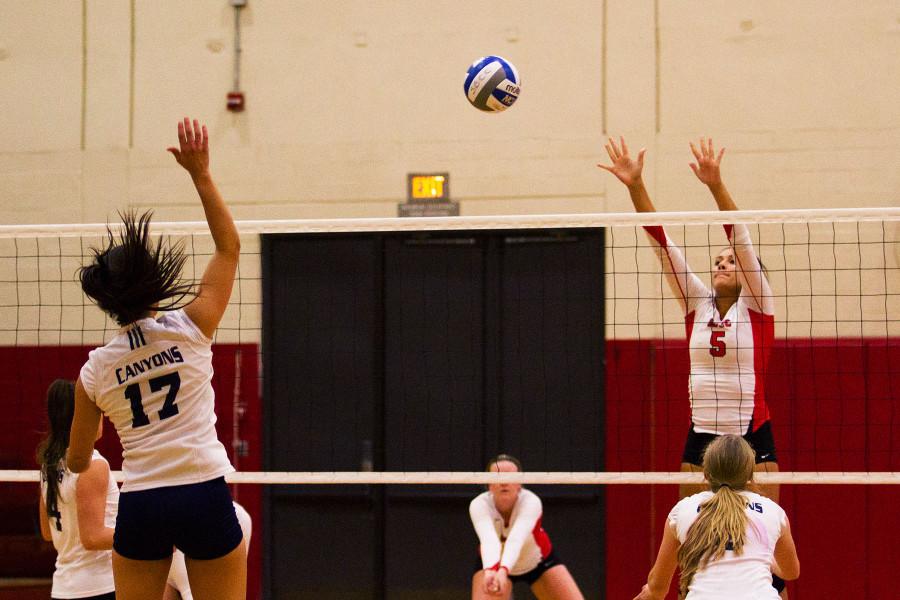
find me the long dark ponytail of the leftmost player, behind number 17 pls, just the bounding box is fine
[37,379,75,516]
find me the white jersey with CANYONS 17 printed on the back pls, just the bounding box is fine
[80,310,234,492]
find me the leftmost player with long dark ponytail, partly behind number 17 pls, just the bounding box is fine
[37,379,119,600]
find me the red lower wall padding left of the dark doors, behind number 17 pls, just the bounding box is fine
[0,344,262,599]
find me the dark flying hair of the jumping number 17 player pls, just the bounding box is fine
[78,211,196,325]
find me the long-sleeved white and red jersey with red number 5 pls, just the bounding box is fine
[645,225,775,435]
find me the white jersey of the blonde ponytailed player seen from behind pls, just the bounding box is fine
[668,491,787,600]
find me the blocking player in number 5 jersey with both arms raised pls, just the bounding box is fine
[598,138,778,501]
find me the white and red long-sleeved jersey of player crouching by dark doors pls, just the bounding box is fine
[469,488,553,575]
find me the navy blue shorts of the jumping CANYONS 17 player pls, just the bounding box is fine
[113,477,243,560]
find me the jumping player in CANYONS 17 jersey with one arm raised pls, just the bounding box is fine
[67,119,247,600]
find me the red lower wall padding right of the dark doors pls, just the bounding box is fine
[606,339,900,600]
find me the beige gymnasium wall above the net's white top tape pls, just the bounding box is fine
[0,0,900,225]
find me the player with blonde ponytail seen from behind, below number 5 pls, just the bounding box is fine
[635,435,800,600]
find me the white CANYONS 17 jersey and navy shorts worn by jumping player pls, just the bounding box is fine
[80,310,242,560]
